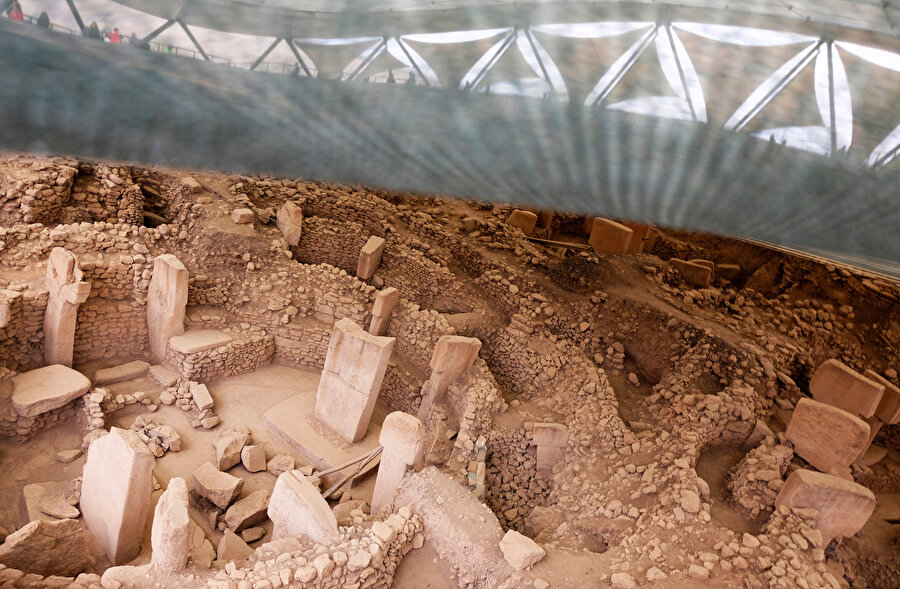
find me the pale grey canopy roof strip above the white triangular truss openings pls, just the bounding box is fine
[110,0,900,39]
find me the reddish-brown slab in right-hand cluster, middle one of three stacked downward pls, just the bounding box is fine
[785,398,869,472]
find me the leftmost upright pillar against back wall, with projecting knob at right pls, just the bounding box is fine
[44,247,91,366]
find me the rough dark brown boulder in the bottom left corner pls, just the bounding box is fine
[0,519,90,577]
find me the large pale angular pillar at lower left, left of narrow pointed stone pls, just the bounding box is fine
[81,427,156,565]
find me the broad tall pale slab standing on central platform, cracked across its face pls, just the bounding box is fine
[316,318,394,442]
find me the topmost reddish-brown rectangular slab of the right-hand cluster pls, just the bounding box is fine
[809,359,884,417]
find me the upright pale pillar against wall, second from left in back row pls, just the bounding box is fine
[147,254,188,362]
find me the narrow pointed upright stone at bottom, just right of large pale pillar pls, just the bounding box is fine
[150,477,191,572]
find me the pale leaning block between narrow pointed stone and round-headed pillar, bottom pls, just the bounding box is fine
[268,470,339,544]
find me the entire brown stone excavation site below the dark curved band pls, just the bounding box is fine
[0,155,900,589]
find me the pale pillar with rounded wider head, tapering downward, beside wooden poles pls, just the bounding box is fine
[371,411,425,514]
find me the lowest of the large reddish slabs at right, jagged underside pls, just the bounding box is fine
[775,469,875,546]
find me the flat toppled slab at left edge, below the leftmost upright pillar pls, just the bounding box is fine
[12,364,91,417]
